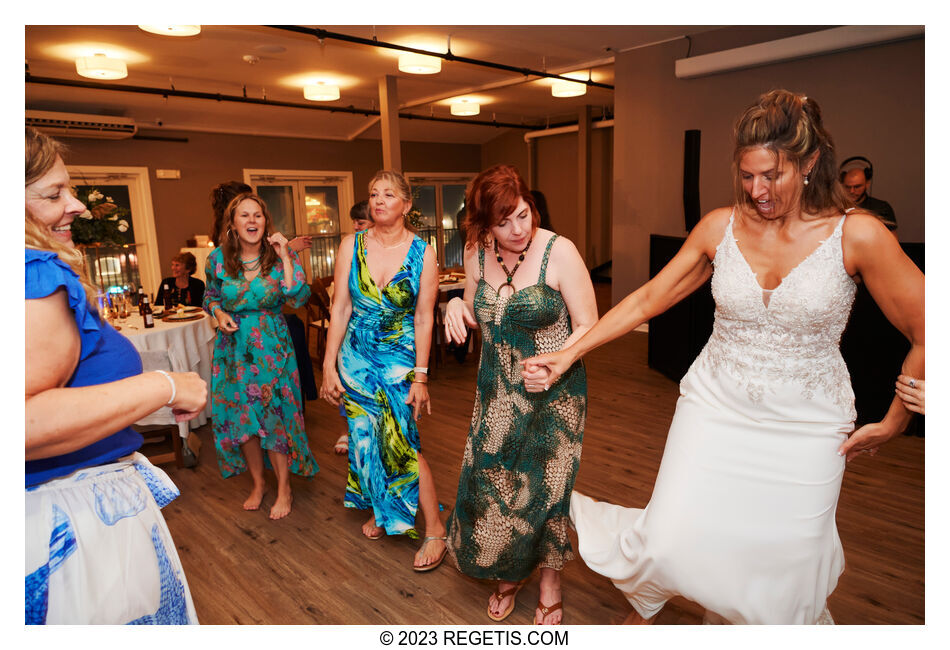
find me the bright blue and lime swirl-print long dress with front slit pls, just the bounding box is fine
[337,232,426,538]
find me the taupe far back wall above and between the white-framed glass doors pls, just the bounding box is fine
[57,132,481,273]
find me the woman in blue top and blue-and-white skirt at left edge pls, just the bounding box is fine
[25,129,207,624]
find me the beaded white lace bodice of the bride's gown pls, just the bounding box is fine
[696,215,856,419]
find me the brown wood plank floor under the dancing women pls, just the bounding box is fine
[164,285,924,625]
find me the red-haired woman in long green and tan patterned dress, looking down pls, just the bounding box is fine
[445,165,597,624]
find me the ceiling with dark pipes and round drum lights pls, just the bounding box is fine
[25,25,714,144]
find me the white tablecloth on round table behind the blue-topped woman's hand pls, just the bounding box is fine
[118,312,216,438]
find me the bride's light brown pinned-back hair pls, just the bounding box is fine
[732,89,854,216]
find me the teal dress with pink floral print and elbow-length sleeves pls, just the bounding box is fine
[204,248,319,478]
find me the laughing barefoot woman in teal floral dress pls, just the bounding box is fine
[204,193,319,519]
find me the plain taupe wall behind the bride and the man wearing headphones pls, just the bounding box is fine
[613,30,924,302]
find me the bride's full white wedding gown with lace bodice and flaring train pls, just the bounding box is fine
[571,210,856,624]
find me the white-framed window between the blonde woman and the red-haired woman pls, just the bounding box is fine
[406,173,475,268]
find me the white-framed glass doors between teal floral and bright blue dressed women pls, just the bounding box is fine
[244,169,353,280]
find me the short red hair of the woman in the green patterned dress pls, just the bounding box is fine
[463,165,541,248]
